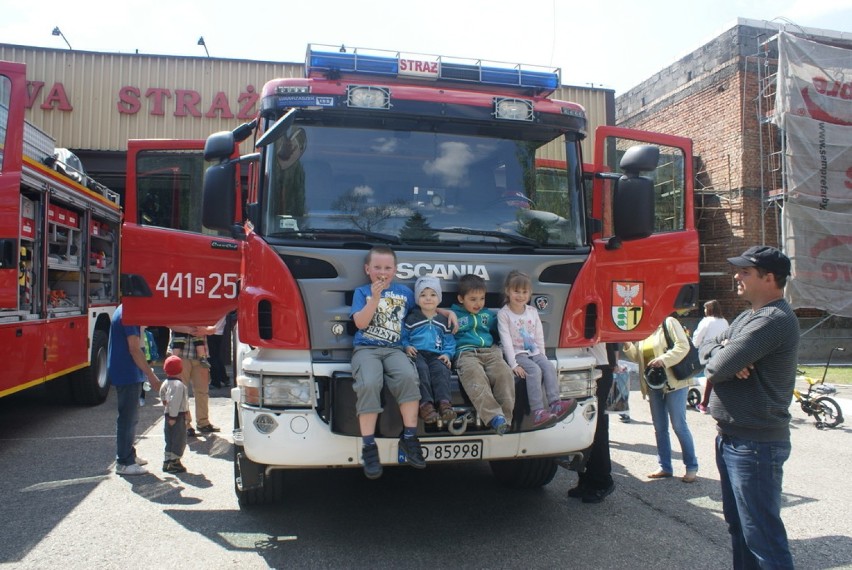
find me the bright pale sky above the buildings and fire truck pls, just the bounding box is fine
[0,0,852,95]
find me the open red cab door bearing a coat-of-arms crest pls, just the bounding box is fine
[563,126,699,342]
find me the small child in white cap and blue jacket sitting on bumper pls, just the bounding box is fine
[402,275,456,424]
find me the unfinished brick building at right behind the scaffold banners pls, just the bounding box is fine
[616,19,852,316]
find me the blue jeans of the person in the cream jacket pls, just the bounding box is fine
[648,388,698,473]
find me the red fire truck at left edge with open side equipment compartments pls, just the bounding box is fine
[0,62,121,404]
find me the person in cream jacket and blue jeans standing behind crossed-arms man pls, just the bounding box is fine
[623,316,698,483]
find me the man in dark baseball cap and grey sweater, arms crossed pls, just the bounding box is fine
[699,245,799,569]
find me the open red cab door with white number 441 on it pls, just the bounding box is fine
[121,140,242,326]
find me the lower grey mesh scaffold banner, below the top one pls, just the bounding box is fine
[783,114,852,317]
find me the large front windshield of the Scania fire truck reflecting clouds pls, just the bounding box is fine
[266,124,584,249]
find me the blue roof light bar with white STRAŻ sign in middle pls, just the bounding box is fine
[305,45,560,94]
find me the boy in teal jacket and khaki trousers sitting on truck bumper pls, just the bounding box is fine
[452,274,515,435]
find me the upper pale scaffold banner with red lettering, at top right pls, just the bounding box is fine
[773,32,852,128]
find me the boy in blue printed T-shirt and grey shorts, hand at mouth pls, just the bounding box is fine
[350,246,426,479]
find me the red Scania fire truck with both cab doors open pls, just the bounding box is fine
[122,46,698,505]
